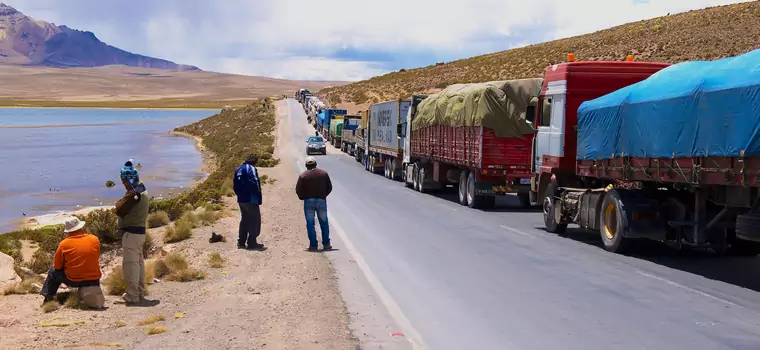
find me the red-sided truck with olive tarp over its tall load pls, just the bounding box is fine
[399,79,543,210]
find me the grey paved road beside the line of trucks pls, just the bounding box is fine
[288,100,760,350]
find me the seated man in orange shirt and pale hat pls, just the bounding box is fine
[41,217,101,302]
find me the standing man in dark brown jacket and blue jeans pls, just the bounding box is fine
[296,156,332,252]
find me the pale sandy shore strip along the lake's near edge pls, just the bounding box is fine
[9,123,216,234]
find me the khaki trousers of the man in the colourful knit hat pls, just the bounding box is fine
[121,232,145,303]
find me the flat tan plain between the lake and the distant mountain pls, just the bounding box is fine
[0,65,344,109]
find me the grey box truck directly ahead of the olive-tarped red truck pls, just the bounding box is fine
[364,99,412,180]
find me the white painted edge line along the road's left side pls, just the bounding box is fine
[296,155,428,350]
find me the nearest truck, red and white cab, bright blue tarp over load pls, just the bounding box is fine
[534,50,760,256]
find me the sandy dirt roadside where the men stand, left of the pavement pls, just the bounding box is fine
[0,100,358,349]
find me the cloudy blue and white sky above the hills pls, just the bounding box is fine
[0,0,756,81]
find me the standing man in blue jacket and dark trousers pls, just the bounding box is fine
[233,155,266,250]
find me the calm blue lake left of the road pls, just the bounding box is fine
[0,108,216,233]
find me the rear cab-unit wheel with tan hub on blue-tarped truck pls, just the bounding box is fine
[599,190,630,253]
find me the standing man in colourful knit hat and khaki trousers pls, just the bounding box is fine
[116,159,150,304]
